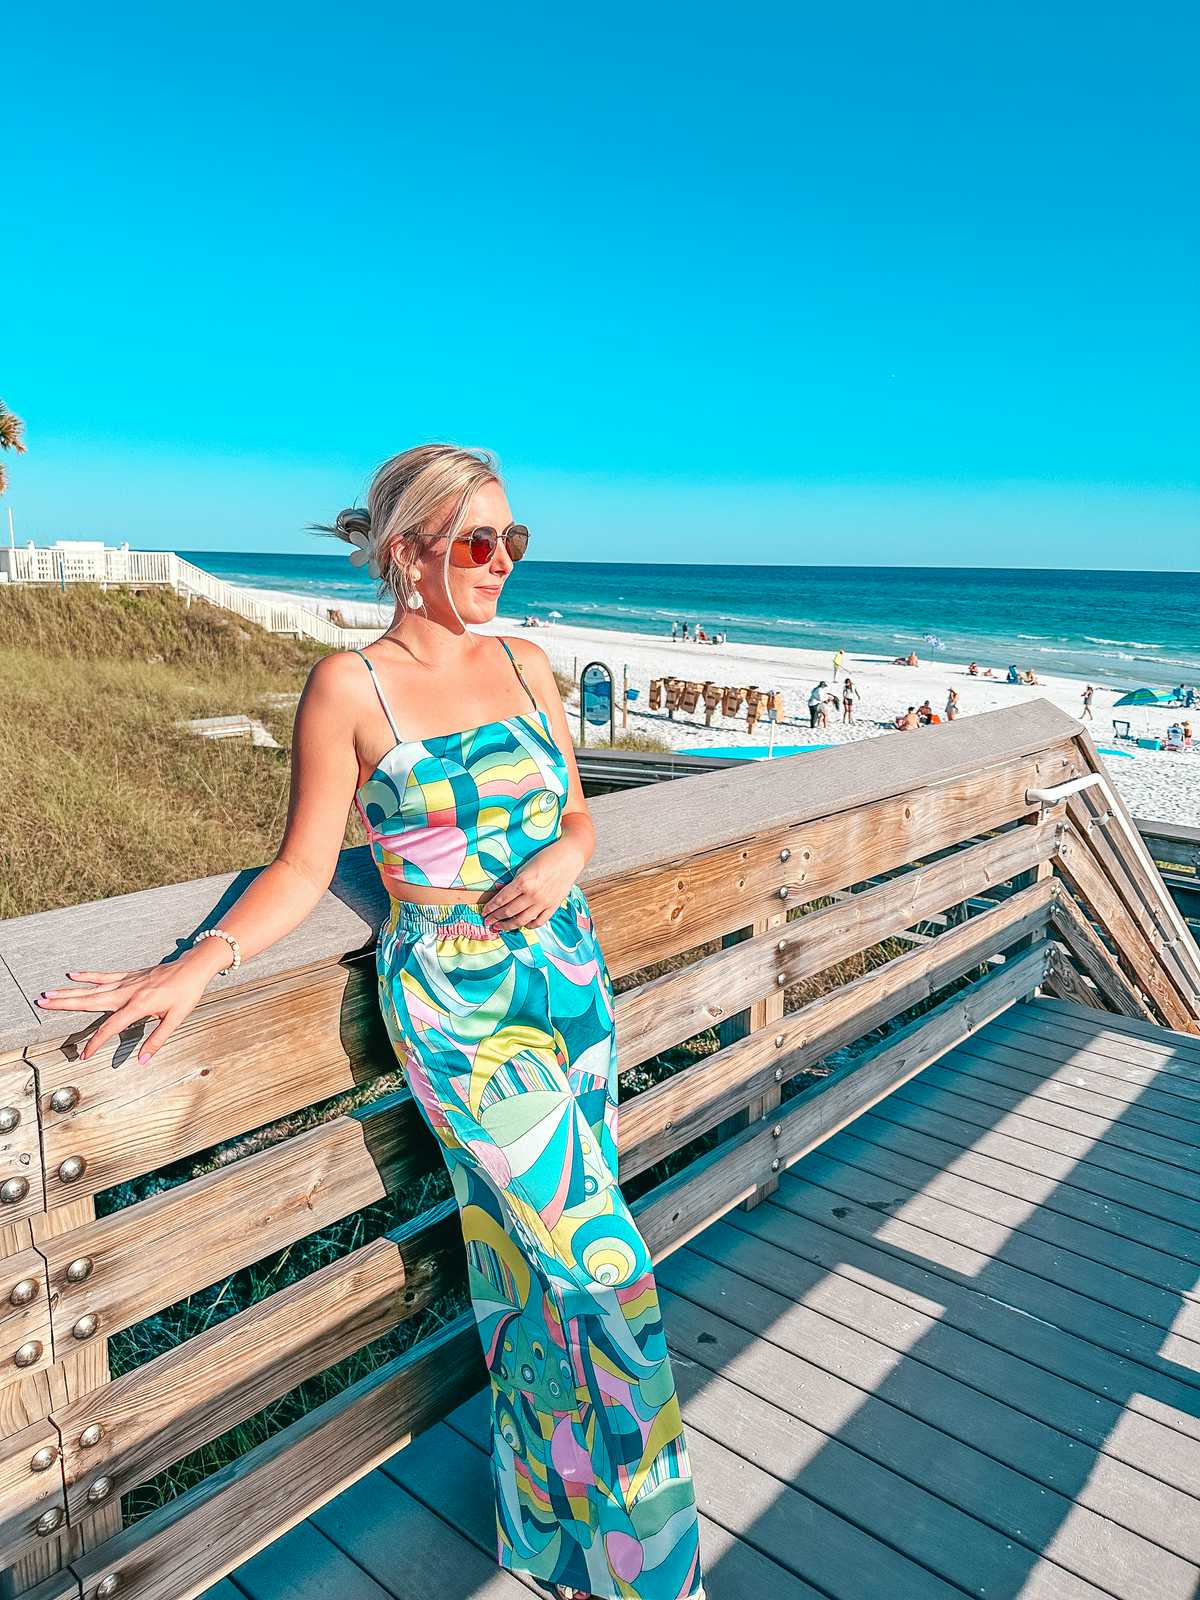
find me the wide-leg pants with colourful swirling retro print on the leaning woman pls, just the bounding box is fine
[376,886,702,1600]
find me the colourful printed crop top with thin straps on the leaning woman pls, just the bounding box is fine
[354,638,568,890]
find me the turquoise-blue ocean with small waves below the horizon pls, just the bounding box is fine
[179,546,1200,688]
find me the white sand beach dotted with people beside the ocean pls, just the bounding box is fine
[254,590,1200,826]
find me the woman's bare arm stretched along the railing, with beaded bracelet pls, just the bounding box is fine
[38,654,366,1061]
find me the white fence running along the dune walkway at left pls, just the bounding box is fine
[0,539,384,650]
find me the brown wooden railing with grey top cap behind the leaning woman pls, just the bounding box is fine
[0,701,1200,1600]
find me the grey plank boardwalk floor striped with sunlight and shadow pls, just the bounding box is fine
[208,998,1200,1600]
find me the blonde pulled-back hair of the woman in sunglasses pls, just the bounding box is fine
[309,445,502,622]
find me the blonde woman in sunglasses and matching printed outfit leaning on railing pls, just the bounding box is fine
[35,445,704,1600]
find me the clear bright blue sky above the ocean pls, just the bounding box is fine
[0,0,1200,568]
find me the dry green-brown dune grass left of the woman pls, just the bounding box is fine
[0,584,362,917]
